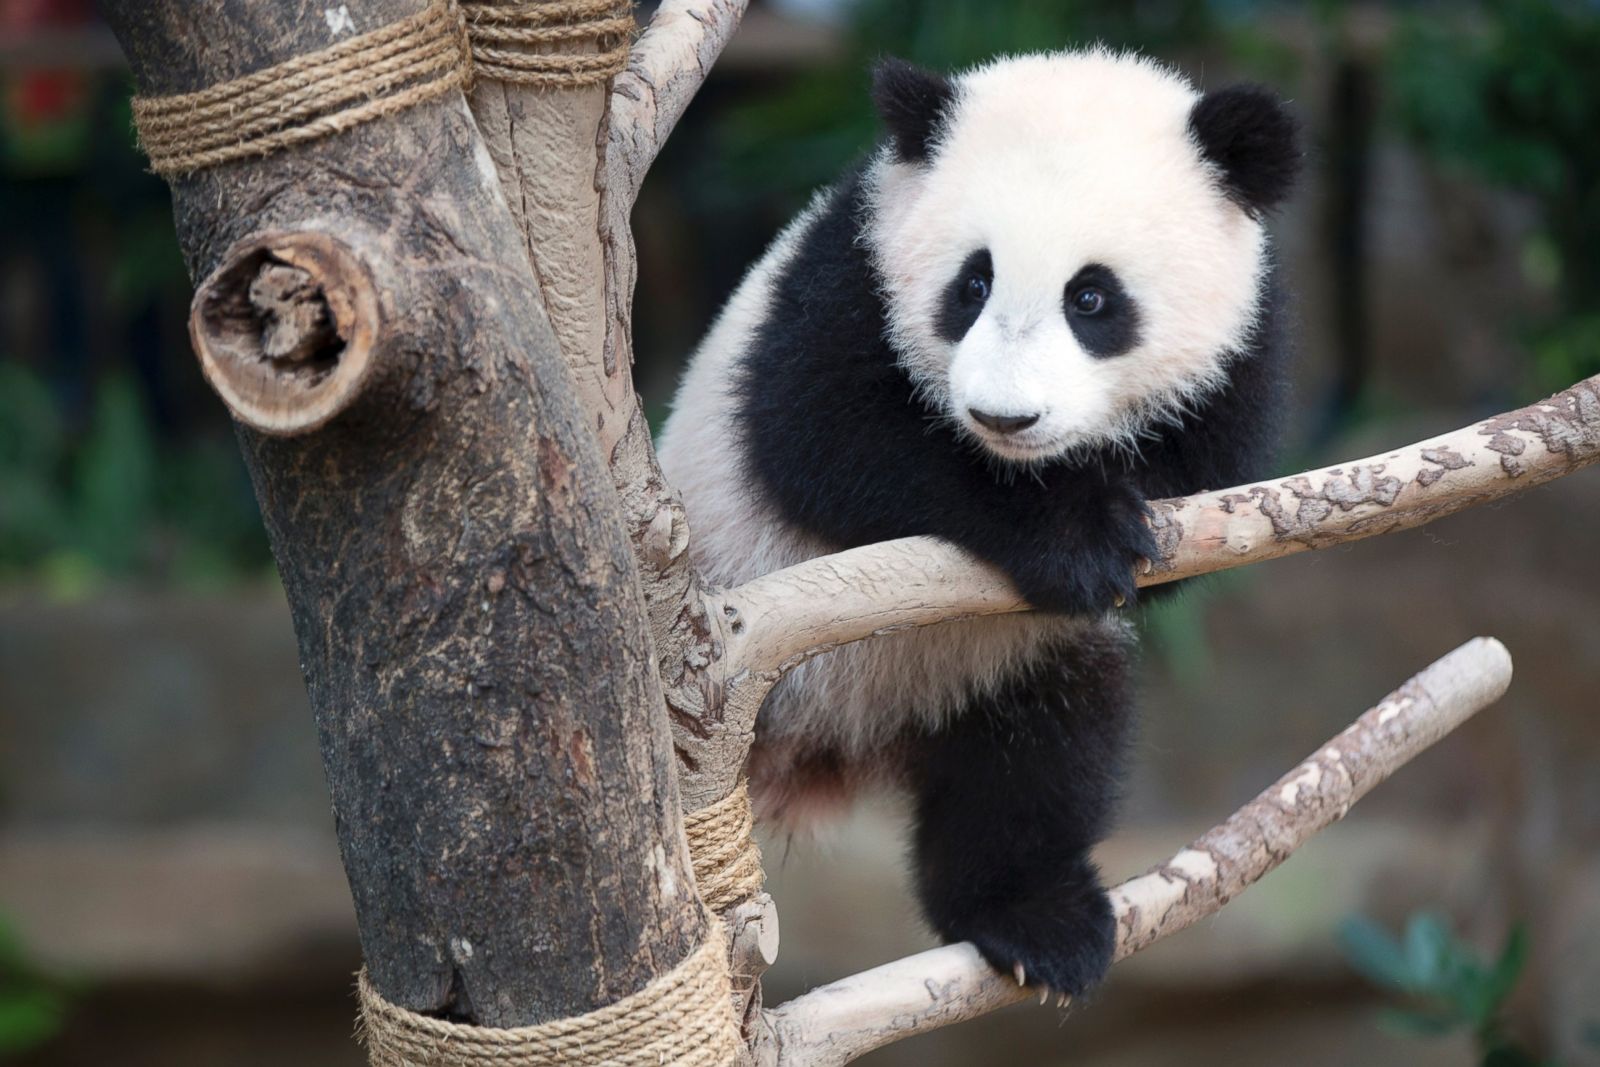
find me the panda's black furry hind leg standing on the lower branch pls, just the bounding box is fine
[910,627,1133,995]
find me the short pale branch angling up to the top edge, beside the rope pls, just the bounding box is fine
[606,0,749,210]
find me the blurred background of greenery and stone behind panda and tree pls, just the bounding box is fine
[0,0,1600,1067]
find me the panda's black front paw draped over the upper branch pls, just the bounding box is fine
[1002,491,1157,616]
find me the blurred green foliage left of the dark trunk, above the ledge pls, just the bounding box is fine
[0,362,269,597]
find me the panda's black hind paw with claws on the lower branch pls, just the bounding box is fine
[946,864,1117,997]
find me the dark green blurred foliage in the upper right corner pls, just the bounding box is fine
[1387,0,1600,389]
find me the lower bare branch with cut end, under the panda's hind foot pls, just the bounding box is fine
[757,637,1512,1067]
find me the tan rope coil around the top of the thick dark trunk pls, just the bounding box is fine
[133,0,470,176]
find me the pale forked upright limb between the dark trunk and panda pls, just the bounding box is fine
[470,0,744,809]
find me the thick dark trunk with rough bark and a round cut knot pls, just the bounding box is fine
[106,0,704,1025]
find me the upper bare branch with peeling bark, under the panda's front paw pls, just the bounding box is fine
[726,376,1600,681]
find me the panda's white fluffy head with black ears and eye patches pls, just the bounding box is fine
[866,50,1299,462]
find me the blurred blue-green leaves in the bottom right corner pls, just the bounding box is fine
[1339,912,1554,1067]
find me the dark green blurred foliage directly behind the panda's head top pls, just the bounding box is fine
[707,0,1293,211]
